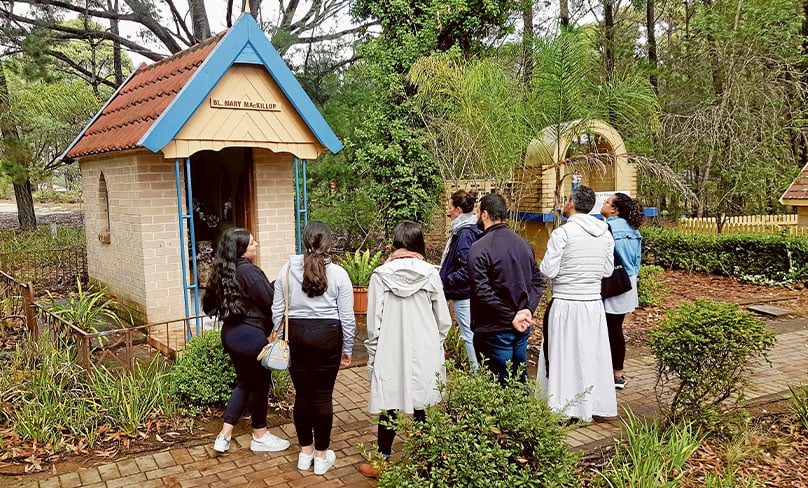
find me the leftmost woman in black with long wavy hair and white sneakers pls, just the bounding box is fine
[202,227,289,453]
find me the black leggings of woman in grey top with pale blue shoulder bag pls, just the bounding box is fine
[289,319,342,451]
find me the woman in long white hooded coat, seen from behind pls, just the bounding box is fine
[360,221,452,477]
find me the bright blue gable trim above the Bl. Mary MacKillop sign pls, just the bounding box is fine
[138,13,343,154]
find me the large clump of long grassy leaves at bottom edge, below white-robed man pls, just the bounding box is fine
[598,410,702,488]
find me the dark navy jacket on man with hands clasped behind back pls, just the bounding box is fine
[468,224,544,334]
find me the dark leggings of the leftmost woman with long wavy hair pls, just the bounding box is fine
[222,324,272,429]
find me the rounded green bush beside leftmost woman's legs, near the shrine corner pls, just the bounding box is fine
[171,330,236,407]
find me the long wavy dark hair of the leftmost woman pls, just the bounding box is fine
[202,227,250,320]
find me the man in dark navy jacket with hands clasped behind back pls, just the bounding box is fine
[468,193,544,382]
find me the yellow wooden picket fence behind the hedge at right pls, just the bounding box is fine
[677,214,808,237]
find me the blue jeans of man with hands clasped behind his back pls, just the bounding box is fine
[474,327,532,384]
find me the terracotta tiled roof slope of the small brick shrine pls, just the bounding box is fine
[65,31,227,159]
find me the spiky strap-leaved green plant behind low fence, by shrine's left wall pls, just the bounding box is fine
[45,280,126,332]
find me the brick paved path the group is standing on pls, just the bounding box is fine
[12,323,808,488]
